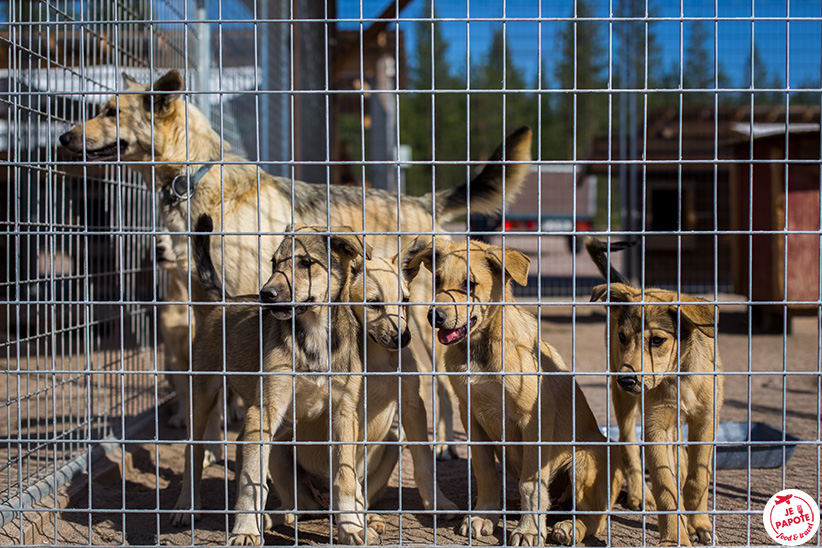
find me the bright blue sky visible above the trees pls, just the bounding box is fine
[337,0,822,88]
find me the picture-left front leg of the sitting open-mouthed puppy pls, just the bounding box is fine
[459,414,502,538]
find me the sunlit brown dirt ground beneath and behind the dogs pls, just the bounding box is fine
[0,303,821,546]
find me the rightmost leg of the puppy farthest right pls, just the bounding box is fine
[682,416,714,544]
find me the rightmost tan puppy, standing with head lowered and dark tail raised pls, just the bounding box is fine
[585,238,723,546]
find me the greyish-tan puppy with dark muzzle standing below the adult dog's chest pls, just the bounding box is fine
[172,215,379,545]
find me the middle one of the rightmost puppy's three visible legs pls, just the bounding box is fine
[645,420,691,546]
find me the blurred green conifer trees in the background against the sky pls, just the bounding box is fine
[399,0,819,194]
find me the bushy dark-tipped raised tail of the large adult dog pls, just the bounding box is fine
[420,126,531,223]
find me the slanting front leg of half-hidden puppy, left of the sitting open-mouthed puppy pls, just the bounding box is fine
[400,358,464,519]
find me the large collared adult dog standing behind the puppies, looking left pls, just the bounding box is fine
[60,70,531,458]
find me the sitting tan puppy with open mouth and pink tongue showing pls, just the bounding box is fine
[409,240,622,546]
